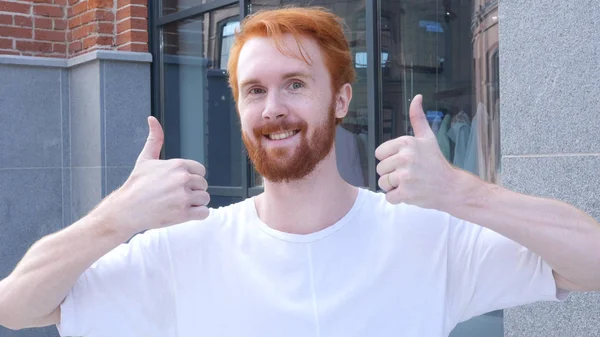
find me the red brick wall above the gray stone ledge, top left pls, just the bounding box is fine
[0,0,148,58]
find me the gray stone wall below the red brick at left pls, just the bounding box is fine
[0,51,151,337]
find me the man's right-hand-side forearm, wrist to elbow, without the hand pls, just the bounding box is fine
[447,171,600,290]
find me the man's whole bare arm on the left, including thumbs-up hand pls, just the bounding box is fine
[0,118,209,329]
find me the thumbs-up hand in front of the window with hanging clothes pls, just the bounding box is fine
[375,95,457,209]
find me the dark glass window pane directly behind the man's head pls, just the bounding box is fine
[250,0,369,186]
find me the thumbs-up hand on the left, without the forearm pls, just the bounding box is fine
[98,117,210,235]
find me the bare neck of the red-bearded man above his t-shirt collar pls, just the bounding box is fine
[256,150,358,234]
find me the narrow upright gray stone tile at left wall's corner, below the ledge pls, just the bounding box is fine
[69,61,104,167]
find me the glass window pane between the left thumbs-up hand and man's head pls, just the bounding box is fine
[162,4,243,188]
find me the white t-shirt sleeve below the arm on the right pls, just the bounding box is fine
[448,217,568,324]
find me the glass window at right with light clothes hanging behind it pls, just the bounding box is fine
[382,0,503,337]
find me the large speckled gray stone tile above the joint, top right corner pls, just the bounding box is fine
[499,0,600,154]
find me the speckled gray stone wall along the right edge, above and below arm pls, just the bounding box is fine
[499,0,600,337]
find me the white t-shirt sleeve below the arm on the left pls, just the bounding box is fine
[57,230,176,337]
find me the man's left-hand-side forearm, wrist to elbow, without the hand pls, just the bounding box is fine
[0,205,127,328]
